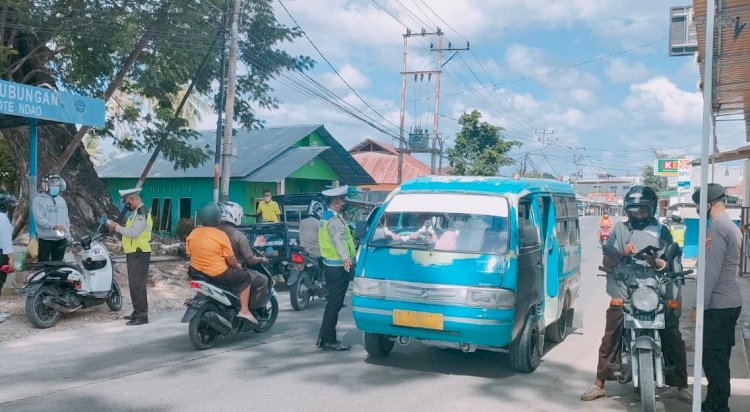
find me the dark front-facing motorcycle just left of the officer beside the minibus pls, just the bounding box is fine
[281,248,326,310]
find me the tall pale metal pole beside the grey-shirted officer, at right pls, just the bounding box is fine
[693,0,716,412]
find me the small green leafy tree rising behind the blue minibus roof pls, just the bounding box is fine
[448,110,520,176]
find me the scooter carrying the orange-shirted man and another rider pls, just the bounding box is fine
[182,251,279,350]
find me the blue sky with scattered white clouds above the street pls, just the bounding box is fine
[191,0,744,176]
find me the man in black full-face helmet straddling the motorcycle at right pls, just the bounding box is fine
[581,186,693,403]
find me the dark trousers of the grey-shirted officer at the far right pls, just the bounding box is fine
[703,307,742,410]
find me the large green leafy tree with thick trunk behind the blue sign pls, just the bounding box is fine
[0,0,314,233]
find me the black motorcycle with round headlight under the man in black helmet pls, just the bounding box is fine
[599,243,693,412]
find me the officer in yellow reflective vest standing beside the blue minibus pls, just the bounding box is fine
[317,186,355,351]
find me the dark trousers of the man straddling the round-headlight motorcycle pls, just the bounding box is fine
[596,306,687,388]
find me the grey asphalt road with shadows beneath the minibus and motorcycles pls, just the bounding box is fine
[0,218,690,412]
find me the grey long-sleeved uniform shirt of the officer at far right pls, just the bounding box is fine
[704,213,742,309]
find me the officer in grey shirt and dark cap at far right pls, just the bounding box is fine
[693,183,742,412]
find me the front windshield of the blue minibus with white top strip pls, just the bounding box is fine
[369,193,509,254]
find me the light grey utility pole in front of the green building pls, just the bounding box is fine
[221,0,241,202]
